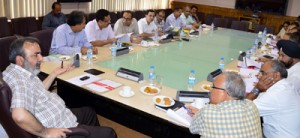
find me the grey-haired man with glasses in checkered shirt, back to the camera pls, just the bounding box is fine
[188,73,262,138]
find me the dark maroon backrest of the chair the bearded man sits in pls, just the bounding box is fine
[0,72,37,138]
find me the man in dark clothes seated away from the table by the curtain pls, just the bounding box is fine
[42,2,67,30]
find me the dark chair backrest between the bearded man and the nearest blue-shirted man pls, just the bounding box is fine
[30,29,54,56]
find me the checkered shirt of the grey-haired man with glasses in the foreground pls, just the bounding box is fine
[190,100,262,138]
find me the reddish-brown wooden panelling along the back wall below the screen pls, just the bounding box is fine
[171,1,296,34]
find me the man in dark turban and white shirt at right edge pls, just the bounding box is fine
[277,40,300,95]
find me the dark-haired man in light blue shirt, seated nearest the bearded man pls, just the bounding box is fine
[50,11,98,55]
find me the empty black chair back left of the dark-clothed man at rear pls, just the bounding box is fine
[11,17,38,36]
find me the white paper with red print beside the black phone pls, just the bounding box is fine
[67,73,100,86]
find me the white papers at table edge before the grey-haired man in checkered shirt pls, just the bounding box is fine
[167,107,193,127]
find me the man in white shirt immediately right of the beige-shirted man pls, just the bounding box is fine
[138,10,157,37]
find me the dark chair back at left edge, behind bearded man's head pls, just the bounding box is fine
[0,36,17,71]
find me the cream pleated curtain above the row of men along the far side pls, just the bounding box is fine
[90,0,169,12]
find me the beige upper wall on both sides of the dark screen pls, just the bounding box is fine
[172,0,300,17]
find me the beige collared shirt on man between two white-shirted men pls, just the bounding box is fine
[114,18,139,35]
